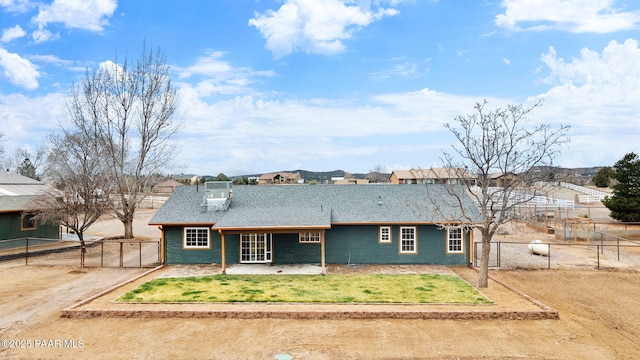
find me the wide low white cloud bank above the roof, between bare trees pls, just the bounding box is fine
[170,80,490,174]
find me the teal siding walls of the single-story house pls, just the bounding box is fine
[165,225,470,265]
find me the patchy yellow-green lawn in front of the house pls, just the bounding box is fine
[117,274,491,304]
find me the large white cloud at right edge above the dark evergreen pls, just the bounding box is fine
[536,39,640,166]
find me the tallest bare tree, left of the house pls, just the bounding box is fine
[66,47,179,239]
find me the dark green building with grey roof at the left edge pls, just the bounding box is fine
[0,170,60,242]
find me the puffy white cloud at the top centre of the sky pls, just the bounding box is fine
[249,0,398,58]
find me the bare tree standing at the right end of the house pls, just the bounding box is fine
[443,100,569,287]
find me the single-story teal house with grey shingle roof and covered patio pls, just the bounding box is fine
[149,182,479,271]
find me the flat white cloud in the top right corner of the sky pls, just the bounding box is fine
[495,0,640,34]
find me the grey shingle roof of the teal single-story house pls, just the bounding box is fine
[149,184,479,228]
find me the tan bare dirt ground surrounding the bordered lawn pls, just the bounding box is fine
[0,205,640,359]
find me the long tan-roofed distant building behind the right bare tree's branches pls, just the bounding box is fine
[389,168,476,184]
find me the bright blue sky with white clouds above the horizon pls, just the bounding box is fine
[0,0,640,175]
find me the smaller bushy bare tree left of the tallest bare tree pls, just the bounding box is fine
[30,133,112,266]
